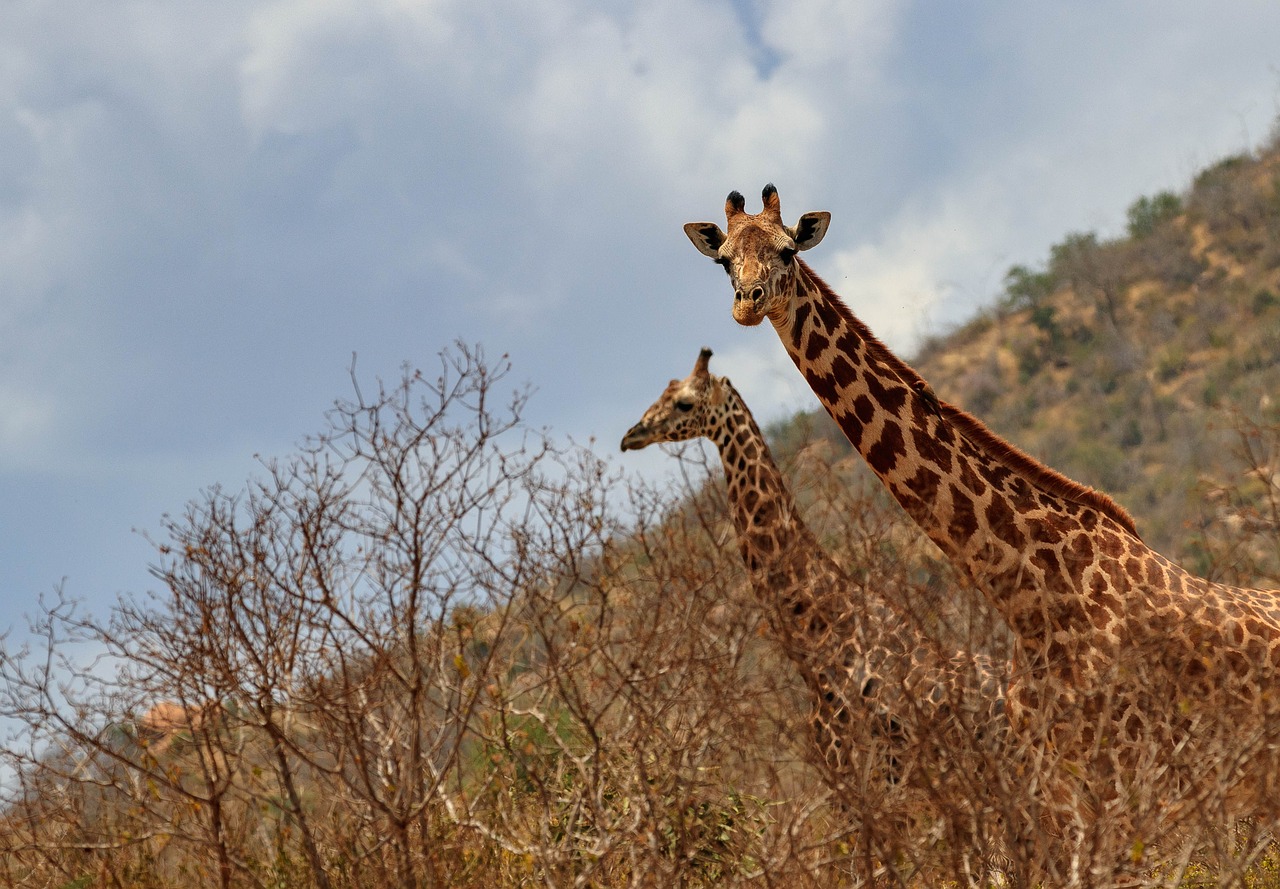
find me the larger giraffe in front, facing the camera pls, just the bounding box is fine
[685,184,1280,879]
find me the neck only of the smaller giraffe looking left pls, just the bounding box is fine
[708,380,904,647]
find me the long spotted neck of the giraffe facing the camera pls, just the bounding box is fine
[771,260,1146,643]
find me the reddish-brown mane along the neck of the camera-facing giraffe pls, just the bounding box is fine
[795,257,1140,539]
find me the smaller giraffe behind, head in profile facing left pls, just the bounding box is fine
[622,349,1007,839]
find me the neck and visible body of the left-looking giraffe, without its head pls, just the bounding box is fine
[705,380,1005,771]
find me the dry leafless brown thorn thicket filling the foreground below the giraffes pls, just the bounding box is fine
[0,345,1277,889]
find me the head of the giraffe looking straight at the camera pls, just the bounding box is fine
[685,184,831,326]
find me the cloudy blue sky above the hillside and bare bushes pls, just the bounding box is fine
[0,0,1280,628]
